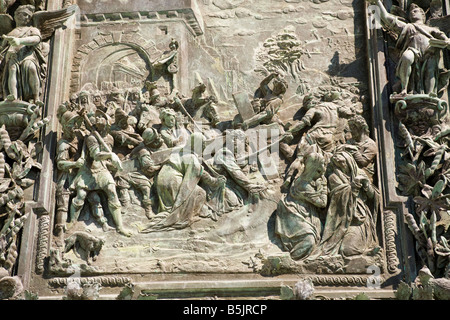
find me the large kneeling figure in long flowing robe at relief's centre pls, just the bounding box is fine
[141,132,225,233]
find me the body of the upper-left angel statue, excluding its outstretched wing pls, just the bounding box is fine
[0,5,46,104]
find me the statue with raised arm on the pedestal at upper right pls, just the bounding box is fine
[369,0,450,95]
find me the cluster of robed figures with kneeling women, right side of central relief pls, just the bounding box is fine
[275,93,381,269]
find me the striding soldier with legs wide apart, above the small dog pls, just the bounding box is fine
[70,110,131,236]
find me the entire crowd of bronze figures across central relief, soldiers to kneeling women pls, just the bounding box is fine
[55,54,380,272]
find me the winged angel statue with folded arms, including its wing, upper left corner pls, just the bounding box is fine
[0,5,76,104]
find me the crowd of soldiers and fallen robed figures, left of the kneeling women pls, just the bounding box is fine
[55,76,266,236]
